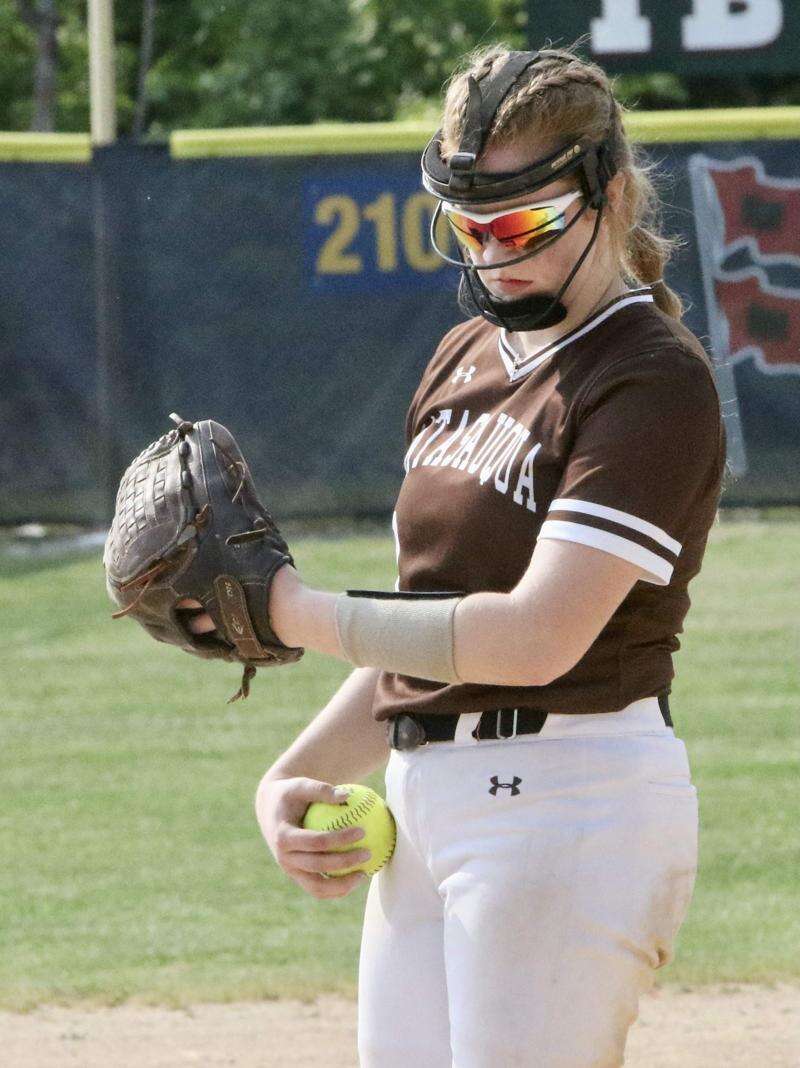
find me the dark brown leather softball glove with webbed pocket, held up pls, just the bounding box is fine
[104,415,303,701]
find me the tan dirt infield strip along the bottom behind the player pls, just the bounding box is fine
[0,986,800,1068]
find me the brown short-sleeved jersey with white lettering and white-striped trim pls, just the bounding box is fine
[374,288,725,719]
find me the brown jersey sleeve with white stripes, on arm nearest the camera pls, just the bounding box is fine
[538,347,724,585]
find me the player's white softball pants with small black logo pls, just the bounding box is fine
[359,698,697,1068]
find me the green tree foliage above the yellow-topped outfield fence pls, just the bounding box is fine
[0,0,800,138]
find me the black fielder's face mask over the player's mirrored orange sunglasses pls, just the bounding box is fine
[422,51,616,330]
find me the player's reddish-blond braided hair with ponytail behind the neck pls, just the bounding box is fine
[441,45,684,319]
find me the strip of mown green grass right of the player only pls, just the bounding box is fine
[664,521,800,983]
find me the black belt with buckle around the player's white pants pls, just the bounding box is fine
[388,693,672,750]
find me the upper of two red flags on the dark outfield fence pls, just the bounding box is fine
[706,157,800,260]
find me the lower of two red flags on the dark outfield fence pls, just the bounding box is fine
[713,268,800,374]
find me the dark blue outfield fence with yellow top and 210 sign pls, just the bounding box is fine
[0,108,800,524]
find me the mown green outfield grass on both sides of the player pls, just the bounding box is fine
[0,521,800,1008]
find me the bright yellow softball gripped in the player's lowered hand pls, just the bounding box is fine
[302,783,397,878]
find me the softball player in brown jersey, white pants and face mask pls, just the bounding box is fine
[198,48,724,1068]
